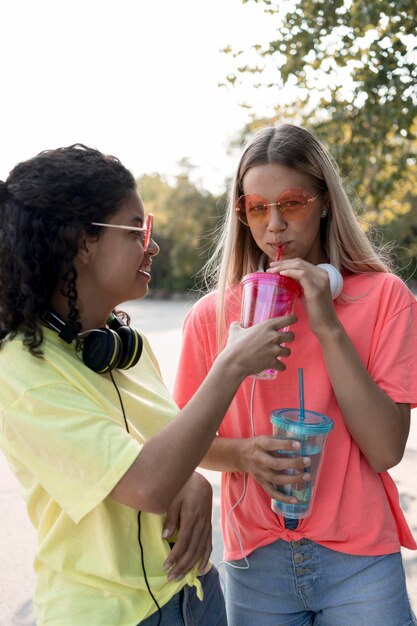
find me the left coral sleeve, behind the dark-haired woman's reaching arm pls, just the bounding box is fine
[173,303,213,409]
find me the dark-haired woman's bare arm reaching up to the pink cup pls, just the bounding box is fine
[111,316,296,513]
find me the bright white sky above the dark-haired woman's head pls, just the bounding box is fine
[0,0,280,192]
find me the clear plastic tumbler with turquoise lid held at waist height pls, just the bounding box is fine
[271,409,334,519]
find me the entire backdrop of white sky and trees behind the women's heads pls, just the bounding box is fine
[0,0,417,297]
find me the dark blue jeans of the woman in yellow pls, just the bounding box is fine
[138,566,227,626]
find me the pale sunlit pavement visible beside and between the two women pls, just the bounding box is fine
[0,300,417,626]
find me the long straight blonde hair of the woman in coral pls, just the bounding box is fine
[204,124,390,348]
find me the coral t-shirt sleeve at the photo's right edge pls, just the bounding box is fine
[368,279,417,408]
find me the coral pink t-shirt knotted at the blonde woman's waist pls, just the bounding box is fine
[174,273,417,560]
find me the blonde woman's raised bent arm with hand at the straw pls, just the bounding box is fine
[272,259,410,472]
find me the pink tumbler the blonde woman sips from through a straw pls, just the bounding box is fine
[240,272,302,380]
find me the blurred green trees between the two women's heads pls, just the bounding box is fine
[138,169,224,295]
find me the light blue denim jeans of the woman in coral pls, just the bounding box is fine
[226,539,417,626]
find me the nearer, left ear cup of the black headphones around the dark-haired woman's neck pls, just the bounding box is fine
[82,328,122,374]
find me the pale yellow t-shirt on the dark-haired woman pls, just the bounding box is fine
[0,329,200,626]
